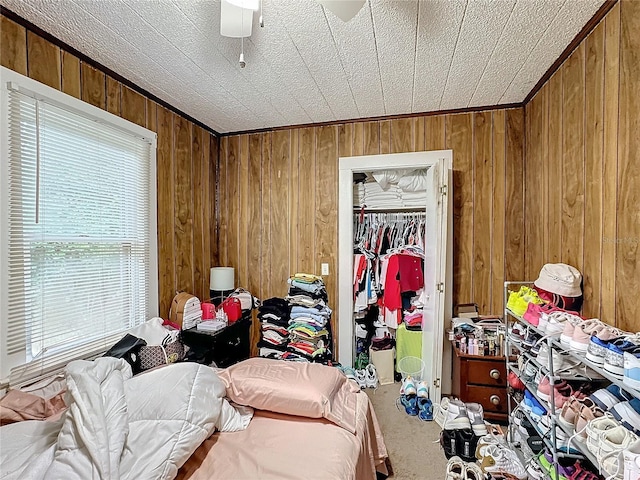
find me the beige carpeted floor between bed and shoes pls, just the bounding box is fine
[366,383,447,480]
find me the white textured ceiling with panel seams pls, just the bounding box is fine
[0,0,604,132]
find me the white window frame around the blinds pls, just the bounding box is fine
[0,67,159,384]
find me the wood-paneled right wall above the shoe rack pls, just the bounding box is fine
[524,0,640,331]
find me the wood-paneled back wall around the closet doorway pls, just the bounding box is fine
[218,109,525,354]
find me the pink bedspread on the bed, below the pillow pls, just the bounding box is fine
[177,392,387,480]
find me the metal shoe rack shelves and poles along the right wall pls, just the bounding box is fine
[504,282,640,478]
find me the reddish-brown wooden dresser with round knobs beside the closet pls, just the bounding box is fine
[451,345,507,422]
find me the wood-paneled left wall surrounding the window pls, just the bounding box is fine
[0,16,218,317]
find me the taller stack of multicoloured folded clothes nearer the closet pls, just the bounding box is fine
[285,273,331,362]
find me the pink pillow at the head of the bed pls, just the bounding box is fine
[218,358,360,433]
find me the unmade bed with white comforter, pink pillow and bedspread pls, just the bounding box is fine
[0,359,387,480]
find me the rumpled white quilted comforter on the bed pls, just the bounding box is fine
[0,358,235,480]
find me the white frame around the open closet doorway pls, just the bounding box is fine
[337,150,453,401]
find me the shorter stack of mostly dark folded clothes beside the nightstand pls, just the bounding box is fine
[258,297,291,359]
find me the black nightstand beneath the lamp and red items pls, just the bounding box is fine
[182,311,251,368]
